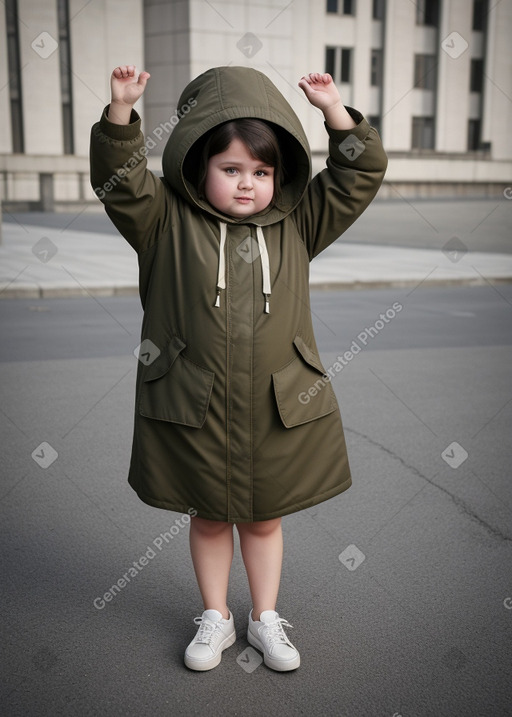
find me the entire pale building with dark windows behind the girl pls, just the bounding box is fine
[0,0,512,209]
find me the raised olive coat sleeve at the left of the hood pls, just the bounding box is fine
[90,107,170,253]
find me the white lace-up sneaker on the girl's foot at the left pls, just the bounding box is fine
[185,610,236,670]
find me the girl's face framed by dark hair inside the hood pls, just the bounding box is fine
[204,138,274,218]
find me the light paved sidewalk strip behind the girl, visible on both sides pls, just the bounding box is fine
[0,222,512,298]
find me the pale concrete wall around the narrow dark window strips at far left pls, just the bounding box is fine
[0,0,144,206]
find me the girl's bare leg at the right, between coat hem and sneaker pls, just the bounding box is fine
[236,518,283,620]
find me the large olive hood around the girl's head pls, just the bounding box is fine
[162,66,311,226]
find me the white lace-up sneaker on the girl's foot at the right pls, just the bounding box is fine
[247,610,300,672]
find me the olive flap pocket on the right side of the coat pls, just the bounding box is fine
[272,336,338,428]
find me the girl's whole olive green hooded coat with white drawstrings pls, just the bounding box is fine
[91,67,387,523]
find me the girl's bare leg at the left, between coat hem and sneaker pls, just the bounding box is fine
[190,516,233,620]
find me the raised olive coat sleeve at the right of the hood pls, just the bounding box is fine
[293,107,387,260]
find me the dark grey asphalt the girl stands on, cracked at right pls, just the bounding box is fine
[0,285,512,717]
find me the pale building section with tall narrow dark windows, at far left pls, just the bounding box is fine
[0,0,144,211]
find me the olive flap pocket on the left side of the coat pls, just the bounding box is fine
[139,336,215,428]
